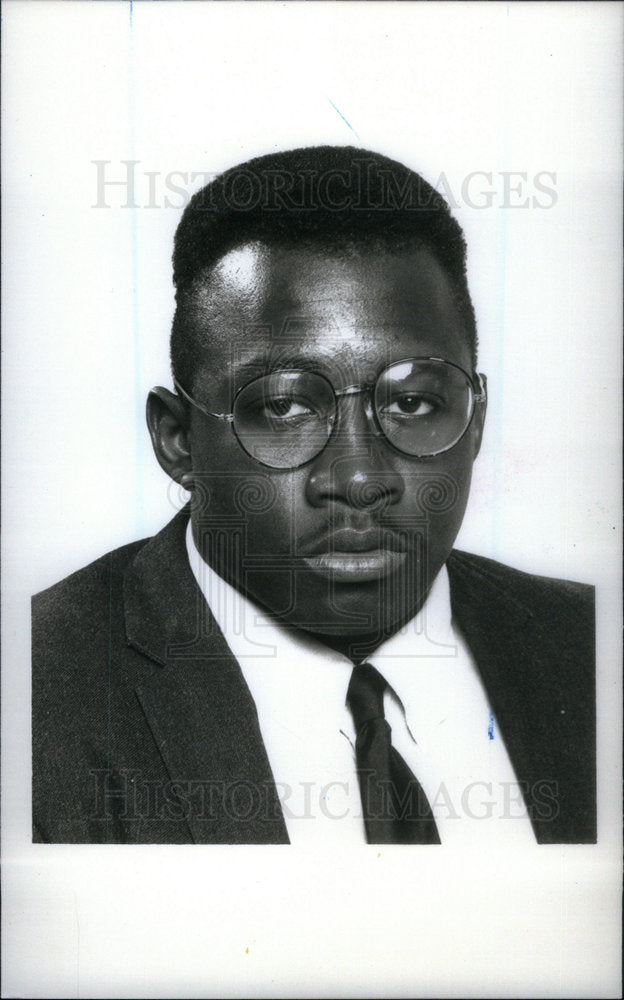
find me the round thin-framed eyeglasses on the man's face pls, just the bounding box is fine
[174,358,487,469]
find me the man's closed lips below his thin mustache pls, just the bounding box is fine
[303,528,407,583]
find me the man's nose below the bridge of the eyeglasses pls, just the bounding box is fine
[306,395,405,511]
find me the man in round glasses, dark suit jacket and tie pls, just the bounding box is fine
[33,147,596,845]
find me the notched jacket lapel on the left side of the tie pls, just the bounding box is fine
[124,510,288,844]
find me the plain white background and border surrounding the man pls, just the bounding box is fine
[3,0,622,997]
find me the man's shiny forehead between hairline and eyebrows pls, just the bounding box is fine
[189,244,470,378]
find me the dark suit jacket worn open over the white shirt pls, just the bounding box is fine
[33,511,596,844]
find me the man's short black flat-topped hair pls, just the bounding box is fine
[171,146,477,391]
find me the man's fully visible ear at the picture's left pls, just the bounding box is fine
[145,386,193,490]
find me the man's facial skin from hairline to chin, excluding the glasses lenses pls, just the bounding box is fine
[180,244,483,642]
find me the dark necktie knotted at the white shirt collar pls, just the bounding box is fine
[347,663,440,844]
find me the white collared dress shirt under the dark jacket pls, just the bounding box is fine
[186,522,535,846]
